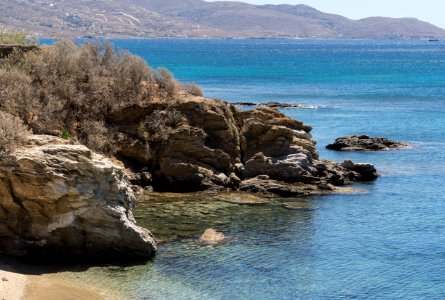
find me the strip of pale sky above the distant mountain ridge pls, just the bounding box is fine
[207,0,445,28]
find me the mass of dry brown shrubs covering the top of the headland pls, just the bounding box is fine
[0,41,202,153]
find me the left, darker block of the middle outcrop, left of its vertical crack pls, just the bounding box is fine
[110,97,241,191]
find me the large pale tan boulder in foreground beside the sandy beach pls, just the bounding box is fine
[0,136,156,261]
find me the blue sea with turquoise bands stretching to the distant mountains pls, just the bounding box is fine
[45,39,445,299]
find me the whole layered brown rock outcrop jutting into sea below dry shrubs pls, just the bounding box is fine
[109,97,377,196]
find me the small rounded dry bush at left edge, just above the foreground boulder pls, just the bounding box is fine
[0,111,30,155]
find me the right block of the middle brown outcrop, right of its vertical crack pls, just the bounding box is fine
[241,108,318,182]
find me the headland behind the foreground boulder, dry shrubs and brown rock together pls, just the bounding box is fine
[0,41,376,195]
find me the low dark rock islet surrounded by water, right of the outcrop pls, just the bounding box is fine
[326,135,407,151]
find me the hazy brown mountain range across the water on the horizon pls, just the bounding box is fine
[0,0,445,38]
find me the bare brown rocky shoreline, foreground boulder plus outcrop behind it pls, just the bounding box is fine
[0,95,378,259]
